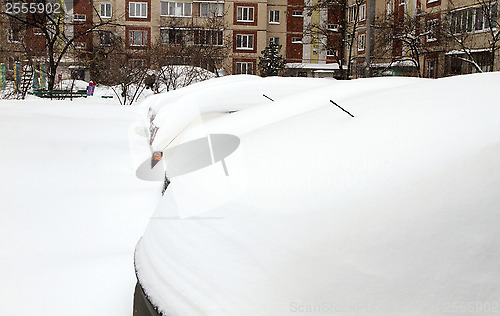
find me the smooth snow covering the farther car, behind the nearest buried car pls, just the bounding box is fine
[143,76,422,155]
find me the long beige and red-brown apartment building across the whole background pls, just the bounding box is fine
[0,0,500,80]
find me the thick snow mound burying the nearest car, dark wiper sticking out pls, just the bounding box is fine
[135,73,500,316]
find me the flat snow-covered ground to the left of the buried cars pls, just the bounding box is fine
[0,97,161,316]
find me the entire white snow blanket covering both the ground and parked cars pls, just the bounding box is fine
[0,73,500,316]
